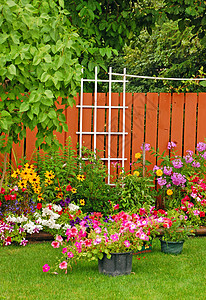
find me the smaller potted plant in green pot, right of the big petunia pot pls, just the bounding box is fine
[159,209,194,254]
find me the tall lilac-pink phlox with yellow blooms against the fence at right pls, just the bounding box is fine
[151,142,206,208]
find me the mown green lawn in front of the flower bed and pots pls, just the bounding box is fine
[0,237,206,300]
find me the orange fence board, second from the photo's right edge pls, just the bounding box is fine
[184,93,197,155]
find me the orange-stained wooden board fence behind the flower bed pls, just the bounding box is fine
[2,93,206,175]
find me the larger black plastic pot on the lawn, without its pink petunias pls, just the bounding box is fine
[98,252,133,276]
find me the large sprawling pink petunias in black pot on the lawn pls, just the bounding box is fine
[43,212,159,276]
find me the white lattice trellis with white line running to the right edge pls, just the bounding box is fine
[77,67,206,184]
